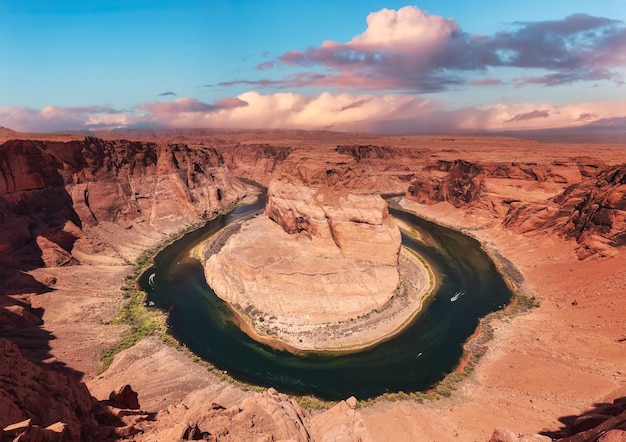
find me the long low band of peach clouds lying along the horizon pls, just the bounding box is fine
[0,91,626,133]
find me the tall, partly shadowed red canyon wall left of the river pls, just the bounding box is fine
[0,137,246,268]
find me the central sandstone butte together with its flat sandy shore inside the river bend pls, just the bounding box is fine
[205,154,434,351]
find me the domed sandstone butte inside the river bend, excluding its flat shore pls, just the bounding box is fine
[206,157,400,345]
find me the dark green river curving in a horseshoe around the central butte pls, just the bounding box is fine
[140,198,512,400]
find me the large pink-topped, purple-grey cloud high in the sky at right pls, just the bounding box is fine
[221,6,626,93]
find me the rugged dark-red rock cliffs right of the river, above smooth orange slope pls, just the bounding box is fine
[406,158,626,259]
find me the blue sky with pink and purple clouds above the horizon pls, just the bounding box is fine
[0,0,626,133]
